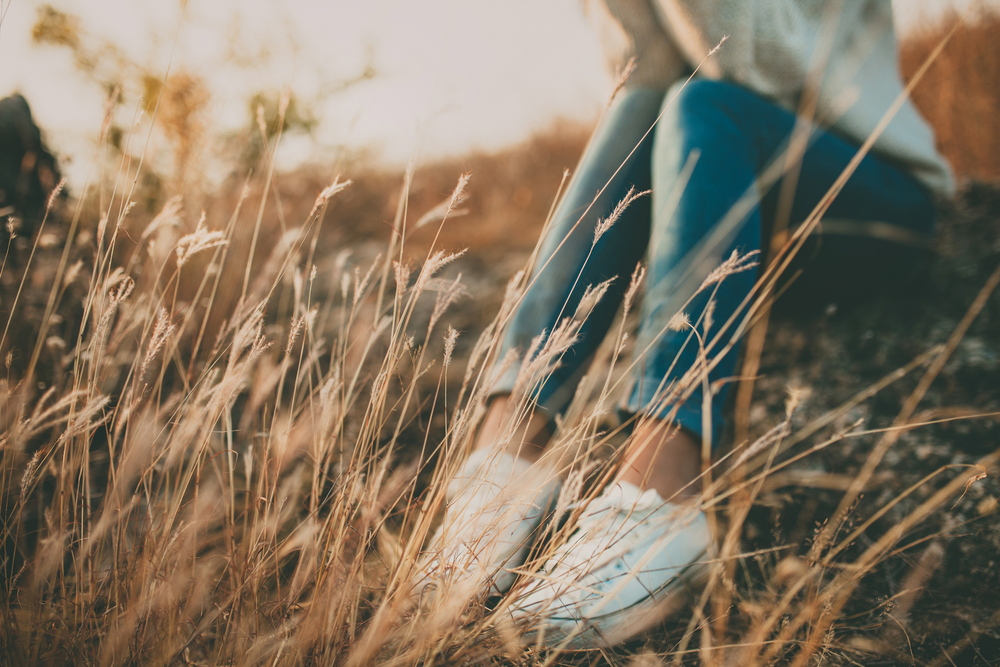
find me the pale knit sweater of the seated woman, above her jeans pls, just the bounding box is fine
[585,0,954,196]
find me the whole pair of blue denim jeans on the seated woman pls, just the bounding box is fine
[491,80,934,442]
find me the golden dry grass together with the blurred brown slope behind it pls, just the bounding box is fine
[0,10,1000,665]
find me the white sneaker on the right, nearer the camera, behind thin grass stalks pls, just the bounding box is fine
[511,482,714,650]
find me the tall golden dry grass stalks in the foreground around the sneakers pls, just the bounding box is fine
[0,18,1000,666]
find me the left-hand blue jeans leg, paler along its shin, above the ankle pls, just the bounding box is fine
[478,89,663,447]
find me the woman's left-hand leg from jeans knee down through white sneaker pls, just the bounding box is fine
[417,85,663,594]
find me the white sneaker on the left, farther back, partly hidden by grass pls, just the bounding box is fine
[416,450,562,595]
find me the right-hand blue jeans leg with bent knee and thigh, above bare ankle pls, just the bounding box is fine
[628,81,934,467]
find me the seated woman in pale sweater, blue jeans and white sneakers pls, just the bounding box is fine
[418,0,953,648]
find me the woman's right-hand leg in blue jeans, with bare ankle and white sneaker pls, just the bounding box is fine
[513,81,933,648]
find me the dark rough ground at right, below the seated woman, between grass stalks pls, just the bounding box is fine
[744,185,1000,665]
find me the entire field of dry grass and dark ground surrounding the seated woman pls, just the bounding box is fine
[0,6,1000,667]
